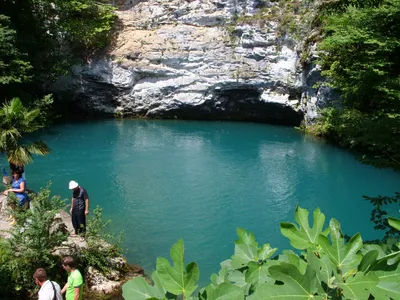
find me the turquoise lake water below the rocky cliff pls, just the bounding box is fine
[14,120,400,286]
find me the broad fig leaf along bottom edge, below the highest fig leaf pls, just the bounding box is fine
[247,263,322,300]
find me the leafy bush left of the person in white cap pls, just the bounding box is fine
[0,185,67,291]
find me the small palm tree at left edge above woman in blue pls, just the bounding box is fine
[0,98,51,166]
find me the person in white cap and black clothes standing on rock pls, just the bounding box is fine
[69,180,89,235]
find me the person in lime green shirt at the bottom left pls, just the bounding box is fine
[61,256,83,300]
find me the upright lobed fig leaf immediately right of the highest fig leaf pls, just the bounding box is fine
[319,219,363,274]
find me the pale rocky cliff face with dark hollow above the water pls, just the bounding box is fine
[54,0,329,125]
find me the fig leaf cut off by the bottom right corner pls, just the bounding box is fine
[372,265,400,300]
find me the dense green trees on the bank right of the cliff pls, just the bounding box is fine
[306,0,400,169]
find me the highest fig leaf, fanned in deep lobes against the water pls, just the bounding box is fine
[281,206,326,250]
